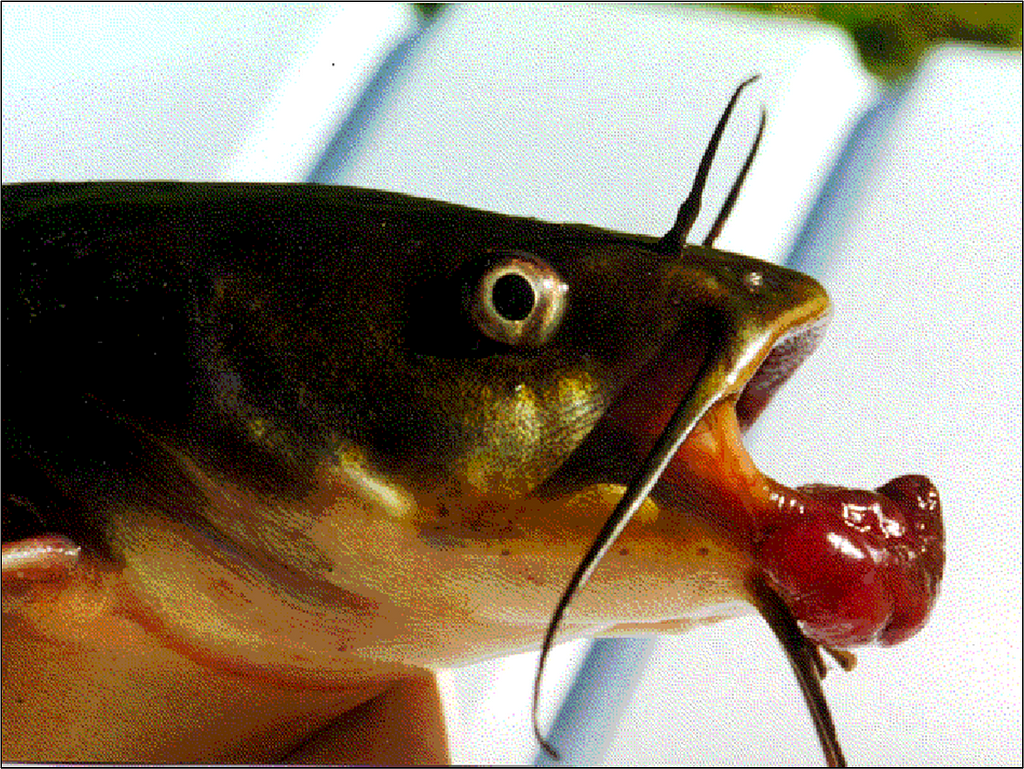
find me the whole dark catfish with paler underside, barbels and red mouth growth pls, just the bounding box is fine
[2,81,944,764]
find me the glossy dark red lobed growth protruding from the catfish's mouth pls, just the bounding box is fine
[756,475,945,647]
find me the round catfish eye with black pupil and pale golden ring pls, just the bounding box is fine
[470,252,568,347]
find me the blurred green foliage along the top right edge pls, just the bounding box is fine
[416,3,1021,80]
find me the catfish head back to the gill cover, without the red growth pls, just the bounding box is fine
[79,187,828,675]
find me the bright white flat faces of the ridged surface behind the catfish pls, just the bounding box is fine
[3,4,1021,766]
